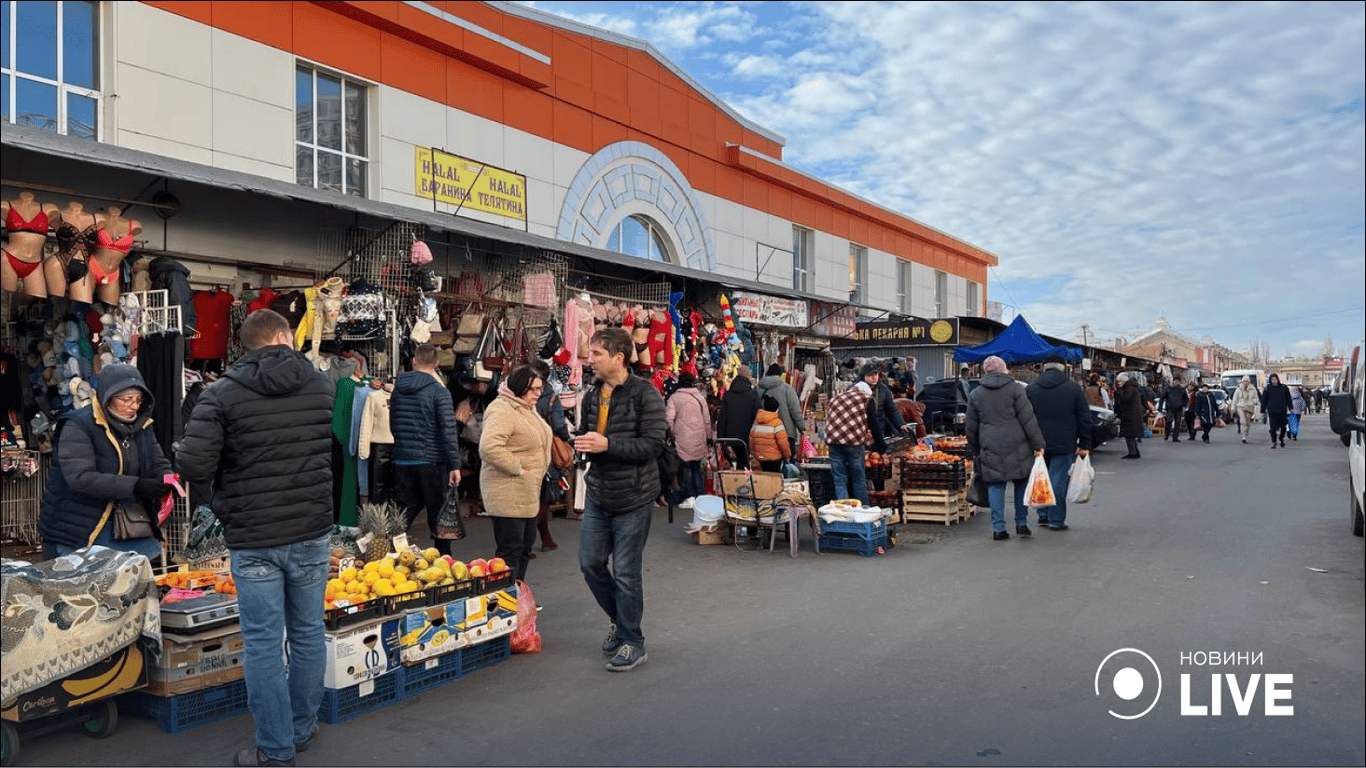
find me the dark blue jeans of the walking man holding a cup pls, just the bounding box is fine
[579,496,654,649]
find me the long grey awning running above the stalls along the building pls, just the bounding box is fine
[0,123,837,308]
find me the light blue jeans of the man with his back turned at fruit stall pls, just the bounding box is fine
[232,534,332,760]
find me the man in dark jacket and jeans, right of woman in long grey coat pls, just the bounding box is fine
[1025,355,1091,530]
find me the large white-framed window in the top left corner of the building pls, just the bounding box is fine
[0,0,100,141]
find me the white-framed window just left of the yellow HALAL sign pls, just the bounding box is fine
[294,64,370,197]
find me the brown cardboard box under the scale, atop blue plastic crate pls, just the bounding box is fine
[148,625,246,696]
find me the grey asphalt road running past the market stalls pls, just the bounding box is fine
[13,415,1366,765]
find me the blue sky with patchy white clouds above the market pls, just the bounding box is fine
[526,0,1366,357]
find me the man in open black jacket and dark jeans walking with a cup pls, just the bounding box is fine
[574,328,668,672]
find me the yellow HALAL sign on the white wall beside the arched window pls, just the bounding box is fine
[414,146,526,221]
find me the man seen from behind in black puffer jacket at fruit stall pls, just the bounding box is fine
[176,309,336,765]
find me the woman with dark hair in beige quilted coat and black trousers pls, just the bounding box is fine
[479,365,550,579]
